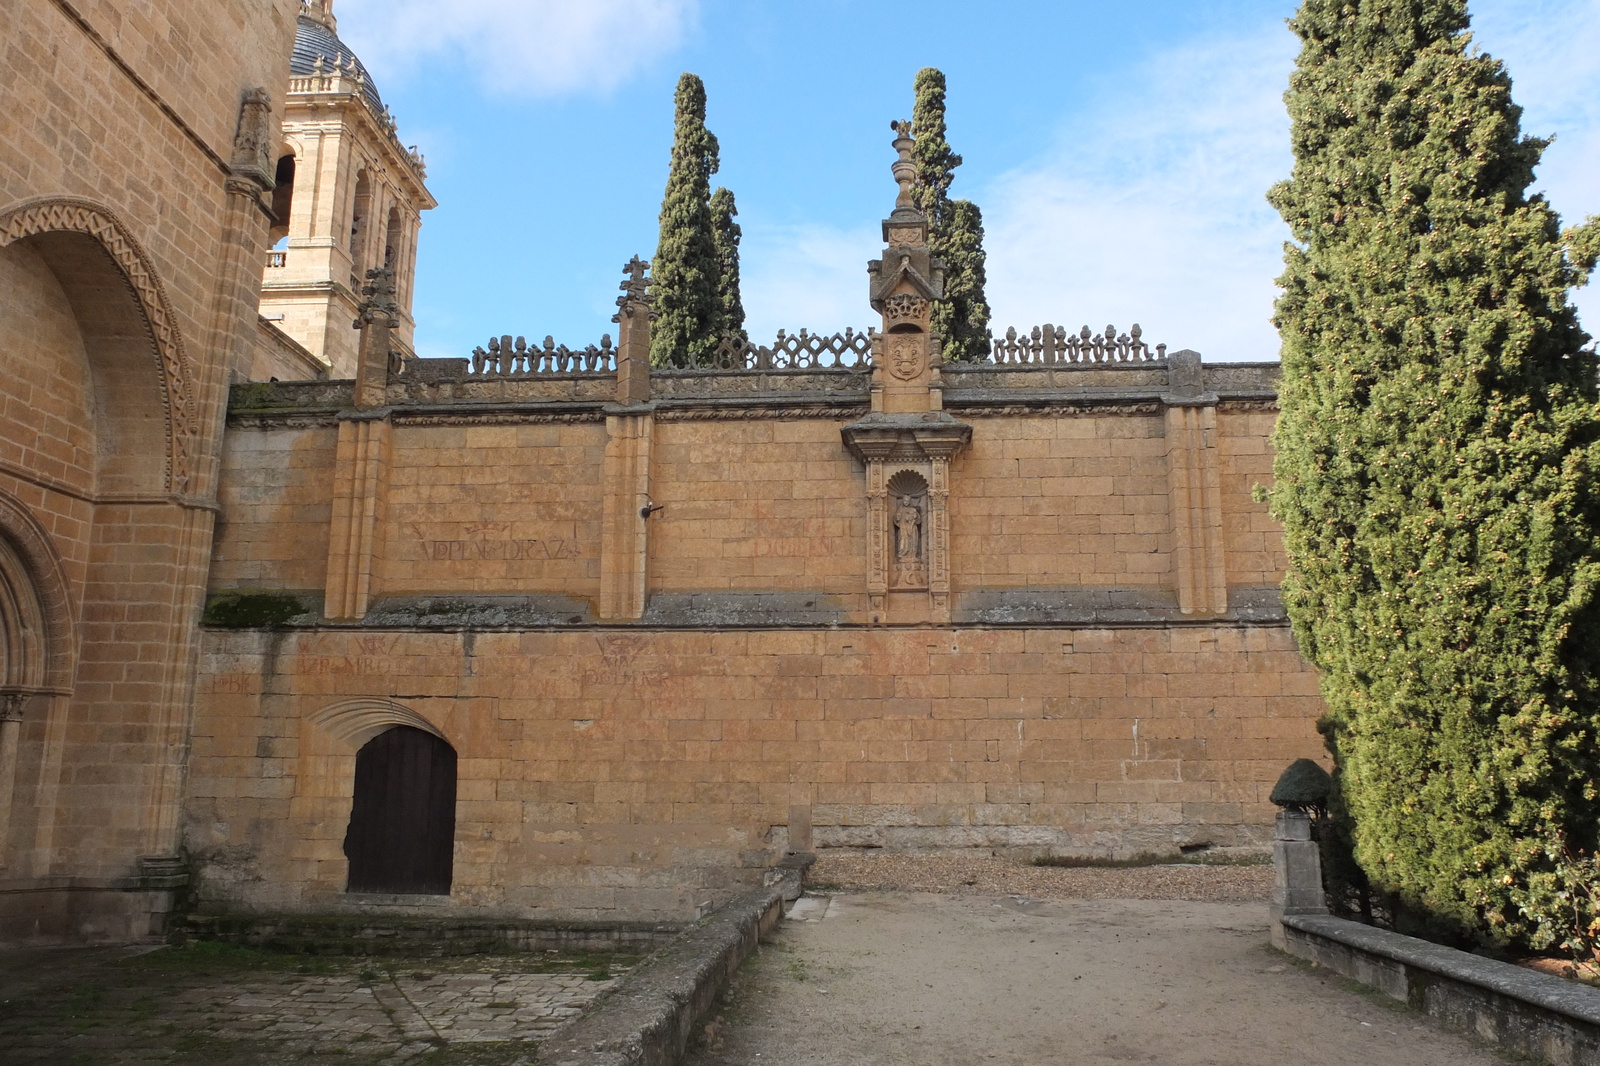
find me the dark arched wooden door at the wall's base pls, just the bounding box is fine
[344,725,456,896]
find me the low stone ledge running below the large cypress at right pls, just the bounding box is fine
[1282,914,1600,1066]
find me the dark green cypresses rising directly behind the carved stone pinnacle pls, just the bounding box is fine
[910,67,989,360]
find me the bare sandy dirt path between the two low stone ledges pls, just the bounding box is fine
[686,889,1506,1066]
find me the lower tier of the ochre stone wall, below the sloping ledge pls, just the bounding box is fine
[189,626,1320,919]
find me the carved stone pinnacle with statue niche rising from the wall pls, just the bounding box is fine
[842,122,973,624]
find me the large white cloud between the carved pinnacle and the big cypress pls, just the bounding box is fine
[979,24,1294,362]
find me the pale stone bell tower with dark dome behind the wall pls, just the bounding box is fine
[261,0,437,378]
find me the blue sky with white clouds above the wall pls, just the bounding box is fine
[334,0,1600,362]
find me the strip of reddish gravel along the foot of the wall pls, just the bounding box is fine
[806,855,1272,903]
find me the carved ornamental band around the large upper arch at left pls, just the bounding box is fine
[0,197,197,493]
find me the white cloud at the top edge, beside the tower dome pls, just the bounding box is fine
[336,0,698,96]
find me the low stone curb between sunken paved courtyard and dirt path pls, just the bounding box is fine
[534,856,810,1066]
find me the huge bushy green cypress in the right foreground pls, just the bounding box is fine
[1270,0,1600,948]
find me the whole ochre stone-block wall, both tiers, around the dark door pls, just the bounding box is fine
[187,356,1322,920]
